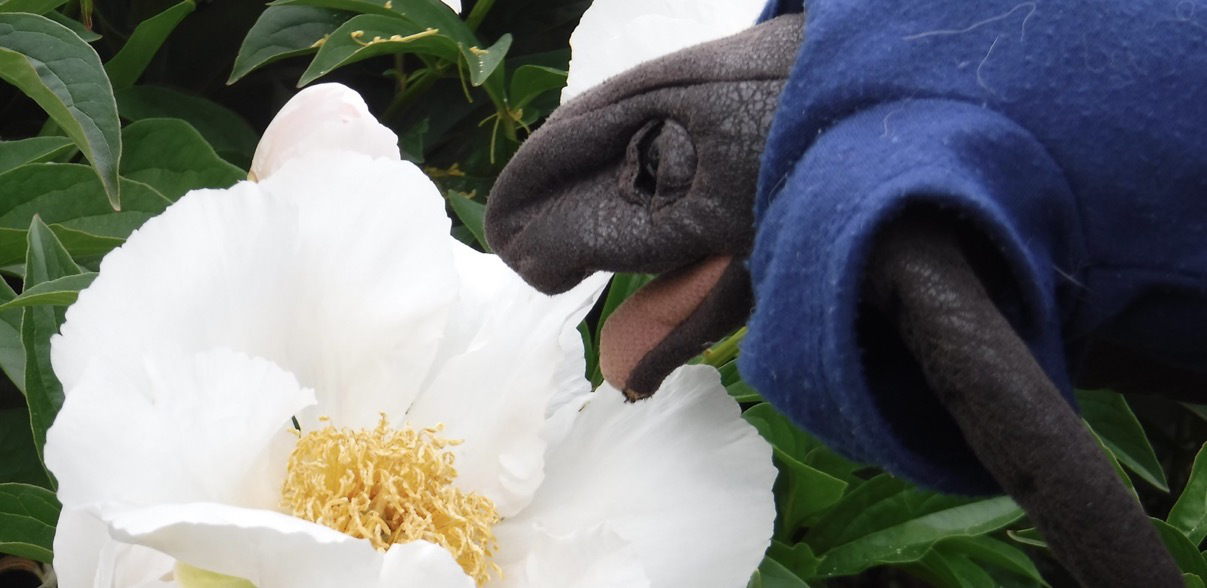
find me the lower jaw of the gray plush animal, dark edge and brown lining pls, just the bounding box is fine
[600,255,750,401]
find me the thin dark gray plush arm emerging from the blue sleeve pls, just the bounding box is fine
[865,216,1183,588]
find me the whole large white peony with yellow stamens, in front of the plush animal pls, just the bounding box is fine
[46,85,776,588]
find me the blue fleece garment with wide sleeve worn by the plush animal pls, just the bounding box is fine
[741,0,1207,493]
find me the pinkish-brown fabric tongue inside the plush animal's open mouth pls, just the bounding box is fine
[600,255,733,391]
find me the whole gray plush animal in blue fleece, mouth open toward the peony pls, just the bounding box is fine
[486,0,1207,587]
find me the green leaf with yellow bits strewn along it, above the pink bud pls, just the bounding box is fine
[298,14,461,86]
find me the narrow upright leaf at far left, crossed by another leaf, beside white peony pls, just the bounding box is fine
[21,216,81,470]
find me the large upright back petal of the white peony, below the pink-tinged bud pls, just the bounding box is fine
[52,153,456,426]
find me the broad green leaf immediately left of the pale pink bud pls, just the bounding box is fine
[122,118,247,200]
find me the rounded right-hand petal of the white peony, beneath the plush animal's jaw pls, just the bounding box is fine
[496,366,776,588]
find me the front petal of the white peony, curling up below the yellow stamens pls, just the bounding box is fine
[105,503,473,588]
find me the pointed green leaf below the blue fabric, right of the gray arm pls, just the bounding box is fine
[1077,390,1170,493]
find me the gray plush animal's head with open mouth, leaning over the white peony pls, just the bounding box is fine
[486,14,803,400]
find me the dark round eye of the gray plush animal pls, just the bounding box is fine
[620,121,696,206]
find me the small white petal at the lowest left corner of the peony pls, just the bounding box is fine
[54,506,175,588]
